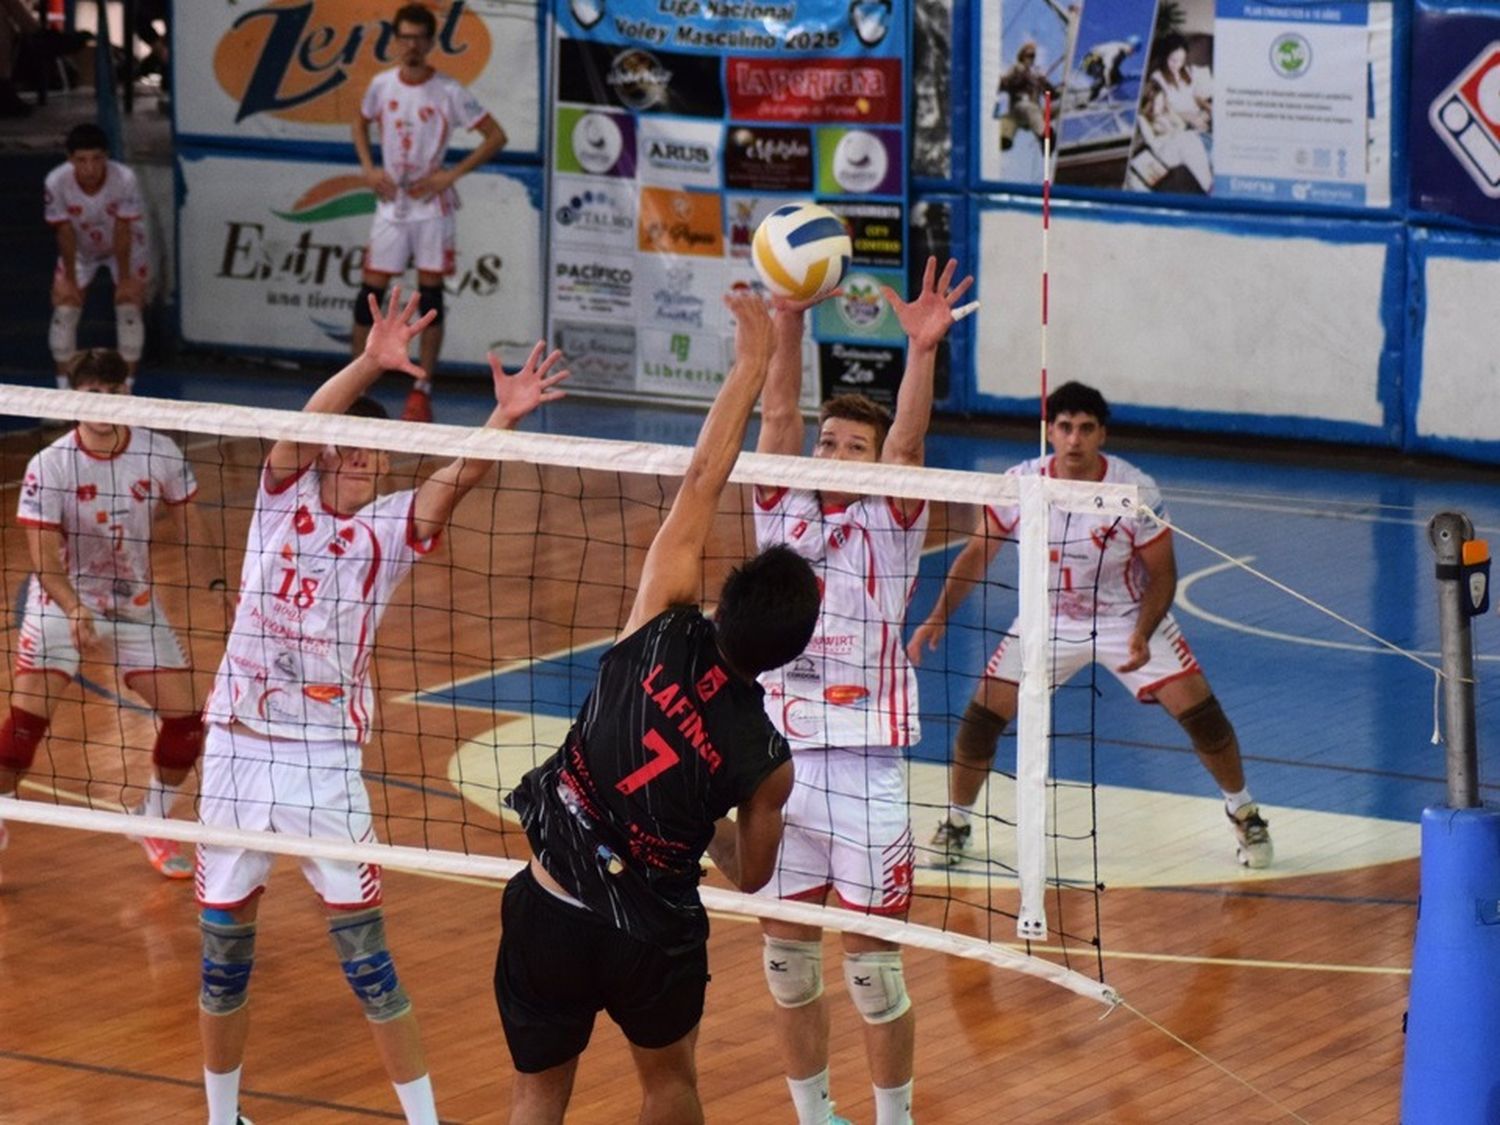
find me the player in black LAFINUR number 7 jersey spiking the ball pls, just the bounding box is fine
[495,290,819,1125]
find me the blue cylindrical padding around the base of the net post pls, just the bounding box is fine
[1401,806,1500,1125]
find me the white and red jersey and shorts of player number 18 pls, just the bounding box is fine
[198,465,437,906]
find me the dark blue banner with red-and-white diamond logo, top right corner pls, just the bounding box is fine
[1410,8,1500,227]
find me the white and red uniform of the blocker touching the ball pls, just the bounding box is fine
[755,489,929,914]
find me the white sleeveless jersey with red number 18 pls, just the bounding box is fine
[204,465,437,744]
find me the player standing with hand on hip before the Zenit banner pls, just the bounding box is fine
[353,5,506,422]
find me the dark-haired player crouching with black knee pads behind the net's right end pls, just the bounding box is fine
[908,383,1272,867]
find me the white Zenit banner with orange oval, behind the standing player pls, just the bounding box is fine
[173,0,542,155]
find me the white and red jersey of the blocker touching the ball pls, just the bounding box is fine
[755,489,929,750]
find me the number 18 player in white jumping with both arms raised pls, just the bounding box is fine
[197,287,567,1125]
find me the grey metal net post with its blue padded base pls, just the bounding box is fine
[1401,512,1500,1125]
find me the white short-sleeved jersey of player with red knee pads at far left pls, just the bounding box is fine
[17,428,198,621]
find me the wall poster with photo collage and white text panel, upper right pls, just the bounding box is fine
[974,0,1392,207]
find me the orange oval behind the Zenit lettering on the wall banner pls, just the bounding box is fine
[213,0,491,125]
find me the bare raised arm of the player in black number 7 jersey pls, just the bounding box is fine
[621,290,773,636]
